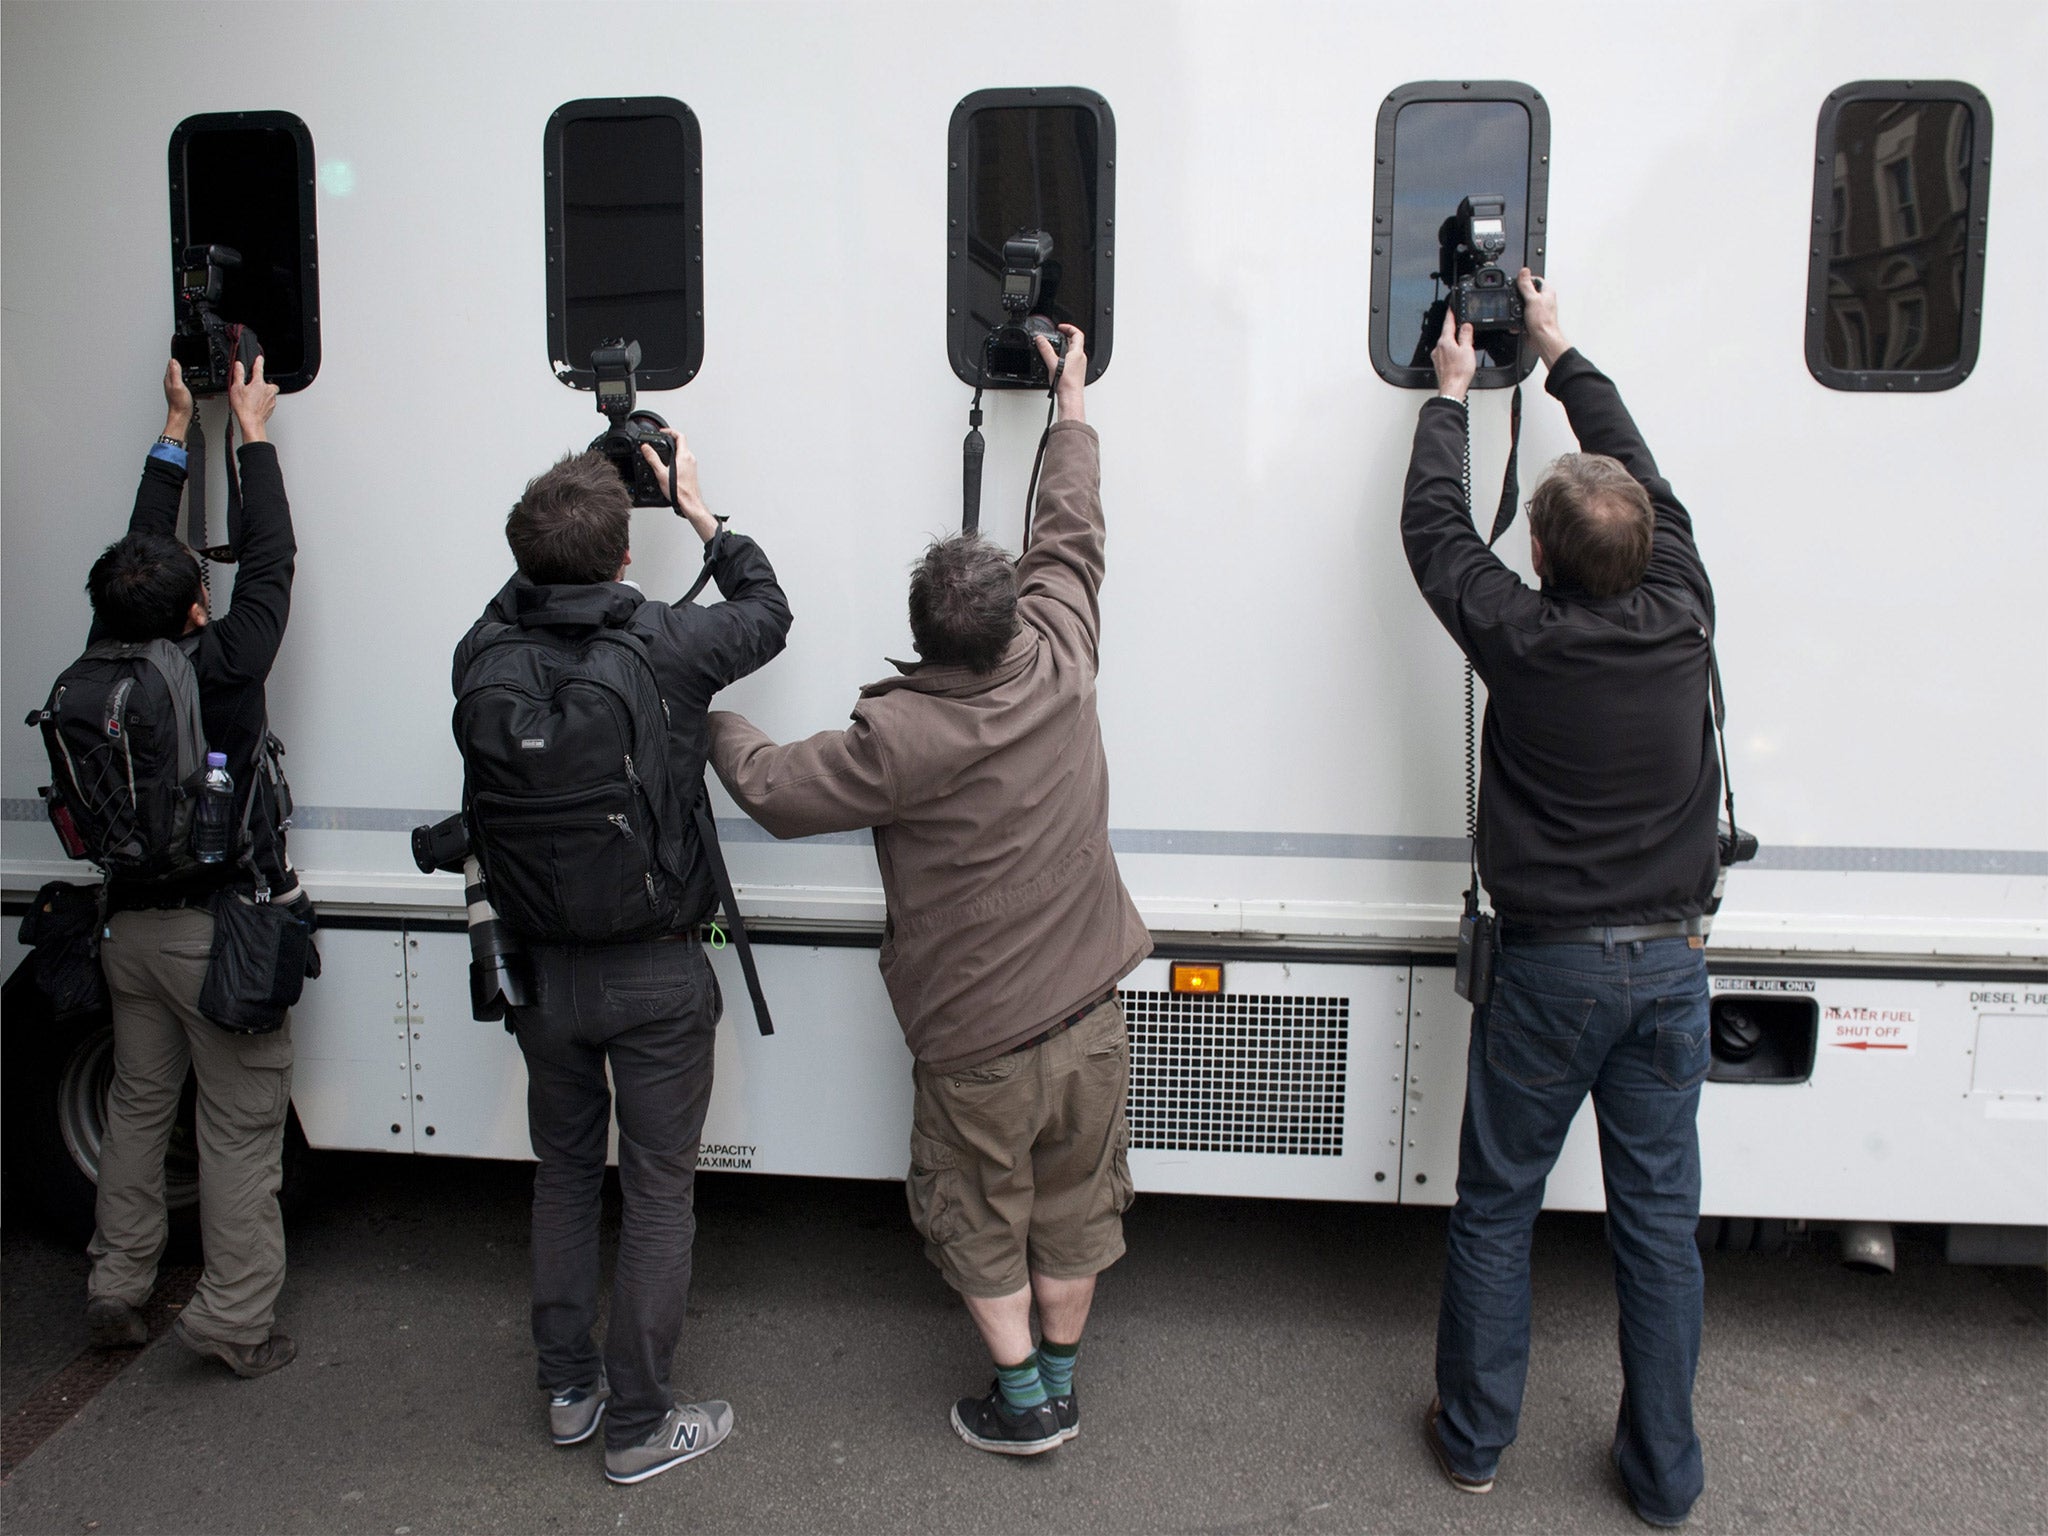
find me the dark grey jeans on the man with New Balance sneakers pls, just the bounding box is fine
[514,938,721,1450]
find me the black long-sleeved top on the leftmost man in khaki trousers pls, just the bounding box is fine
[88,442,299,907]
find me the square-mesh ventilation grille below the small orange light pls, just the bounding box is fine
[1118,991,1352,1157]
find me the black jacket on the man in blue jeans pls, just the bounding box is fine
[1401,350,1720,928]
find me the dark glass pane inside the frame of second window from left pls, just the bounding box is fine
[561,115,694,369]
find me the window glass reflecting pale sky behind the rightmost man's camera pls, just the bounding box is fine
[1386,100,1530,369]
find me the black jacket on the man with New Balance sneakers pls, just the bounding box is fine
[453,528,791,933]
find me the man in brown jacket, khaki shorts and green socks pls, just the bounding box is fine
[711,326,1151,1456]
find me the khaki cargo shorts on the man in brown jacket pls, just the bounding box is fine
[905,997,1133,1296]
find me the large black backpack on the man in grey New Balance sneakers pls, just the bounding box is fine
[455,614,702,944]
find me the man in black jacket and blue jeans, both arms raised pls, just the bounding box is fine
[1401,268,1720,1526]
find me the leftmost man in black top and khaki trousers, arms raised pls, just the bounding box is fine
[86,358,303,1376]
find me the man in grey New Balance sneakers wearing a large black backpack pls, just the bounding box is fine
[455,432,791,1483]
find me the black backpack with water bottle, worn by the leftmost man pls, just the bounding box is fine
[29,635,207,881]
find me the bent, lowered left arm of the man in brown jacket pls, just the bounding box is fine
[707,711,895,838]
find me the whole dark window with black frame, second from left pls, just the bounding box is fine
[547,96,705,389]
